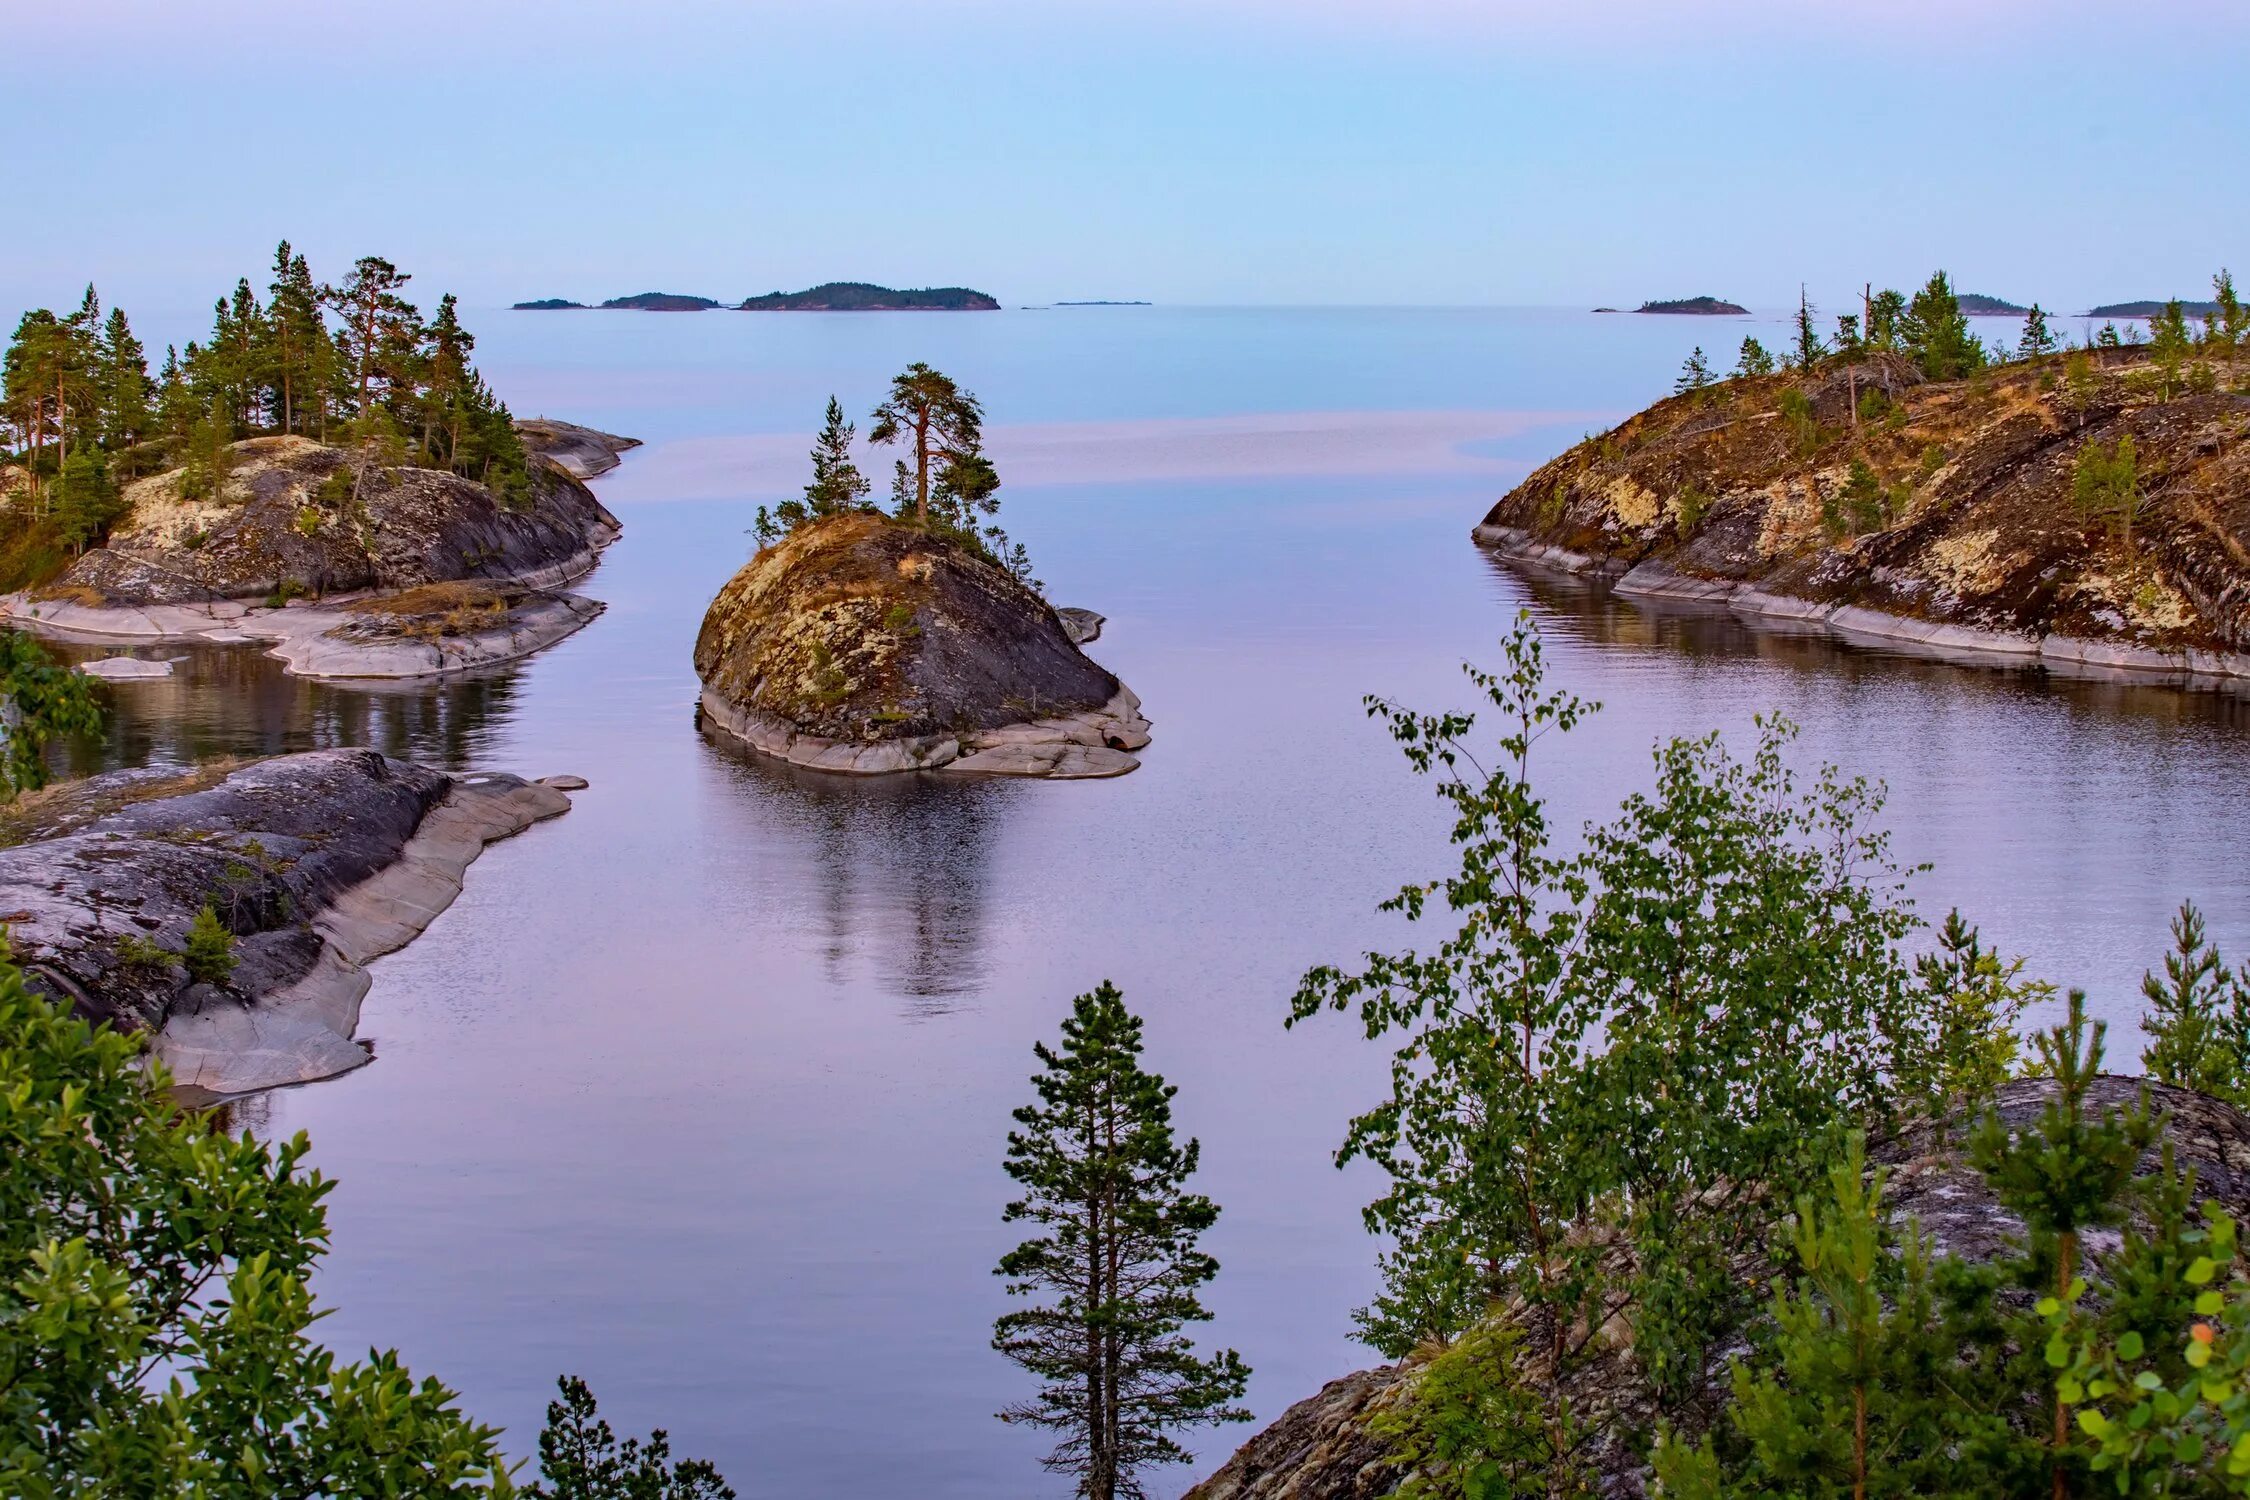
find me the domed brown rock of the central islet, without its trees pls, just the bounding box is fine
[695,515,1148,776]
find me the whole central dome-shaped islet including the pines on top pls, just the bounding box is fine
[695,364,1150,778]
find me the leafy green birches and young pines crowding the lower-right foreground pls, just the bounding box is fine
[1296,625,2250,1500]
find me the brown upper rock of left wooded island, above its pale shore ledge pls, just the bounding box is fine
[43,436,619,605]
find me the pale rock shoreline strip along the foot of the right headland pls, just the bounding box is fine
[1469,524,2250,688]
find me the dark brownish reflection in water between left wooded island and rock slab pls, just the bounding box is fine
[50,643,524,776]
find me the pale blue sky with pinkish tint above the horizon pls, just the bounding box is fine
[0,0,2250,315]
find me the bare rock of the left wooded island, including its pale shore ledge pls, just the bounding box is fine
[0,421,637,677]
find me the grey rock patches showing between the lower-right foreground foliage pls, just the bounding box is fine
[1186,1075,2250,1500]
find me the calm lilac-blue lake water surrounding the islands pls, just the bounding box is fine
[57,308,2250,1500]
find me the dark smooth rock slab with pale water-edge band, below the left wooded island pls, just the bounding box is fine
[0,749,569,1095]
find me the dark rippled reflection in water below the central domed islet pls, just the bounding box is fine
[700,722,1022,1016]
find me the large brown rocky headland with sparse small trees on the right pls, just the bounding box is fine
[1476,274,2250,677]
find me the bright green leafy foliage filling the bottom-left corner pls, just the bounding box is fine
[0,960,731,1500]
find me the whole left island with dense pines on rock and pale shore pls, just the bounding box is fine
[0,243,635,677]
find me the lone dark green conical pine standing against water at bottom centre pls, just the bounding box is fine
[992,983,1249,1500]
